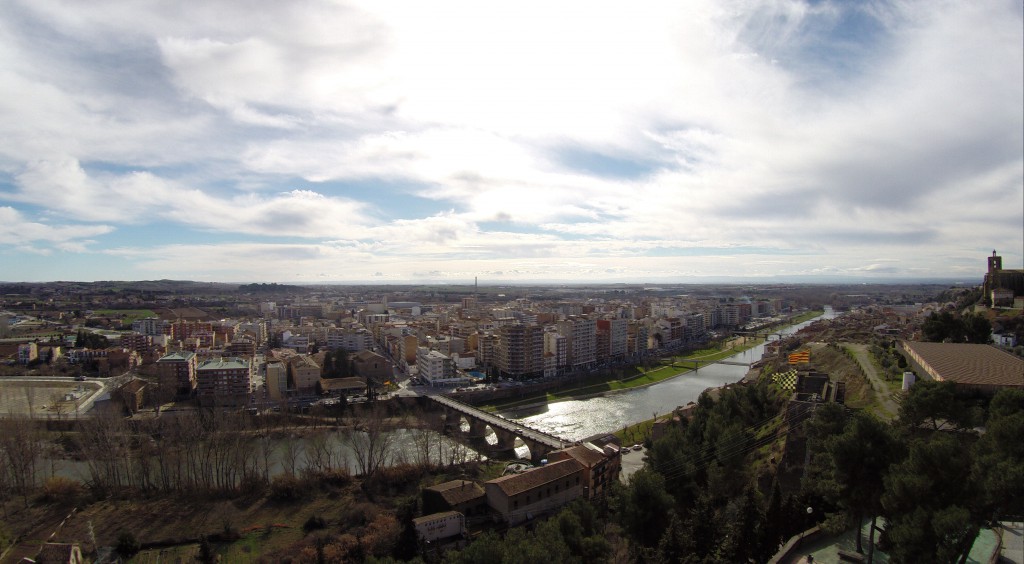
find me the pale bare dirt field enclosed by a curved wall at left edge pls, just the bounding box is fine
[0,379,102,417]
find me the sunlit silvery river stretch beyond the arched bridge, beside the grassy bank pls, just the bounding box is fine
[501,307,836,440]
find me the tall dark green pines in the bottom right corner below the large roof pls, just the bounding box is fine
[806,381,1024,562]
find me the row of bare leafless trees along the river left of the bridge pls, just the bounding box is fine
[0,404,471,505]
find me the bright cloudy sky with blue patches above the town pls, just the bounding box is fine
[0,0,1024,284]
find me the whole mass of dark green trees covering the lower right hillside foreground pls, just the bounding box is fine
[444,382,1024,563]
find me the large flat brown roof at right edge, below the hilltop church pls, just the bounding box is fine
[903,342,1024,387]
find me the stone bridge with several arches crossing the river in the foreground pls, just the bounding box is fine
[429,395,573,463]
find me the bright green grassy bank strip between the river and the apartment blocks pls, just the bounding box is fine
[479,310,823,411]
